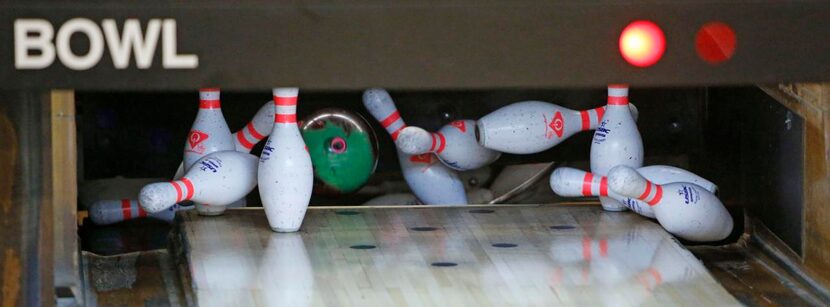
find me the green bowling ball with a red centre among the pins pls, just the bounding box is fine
[300,108,378,194]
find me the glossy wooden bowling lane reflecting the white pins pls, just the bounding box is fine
[179,205,739,306]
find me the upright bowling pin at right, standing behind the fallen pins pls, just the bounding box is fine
[591,84,643,211]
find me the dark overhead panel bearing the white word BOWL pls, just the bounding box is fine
[0,0,830,90]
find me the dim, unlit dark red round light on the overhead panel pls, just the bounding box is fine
[695,21,737,64]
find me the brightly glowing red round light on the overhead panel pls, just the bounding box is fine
[620,20,666,67]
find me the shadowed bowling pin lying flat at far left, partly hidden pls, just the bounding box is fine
[89,199,193,225]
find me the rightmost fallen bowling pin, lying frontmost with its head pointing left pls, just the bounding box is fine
[608,165,732,242]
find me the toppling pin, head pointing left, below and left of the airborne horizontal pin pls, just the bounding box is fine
[395,119,501,171]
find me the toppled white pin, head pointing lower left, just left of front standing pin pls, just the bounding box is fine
[138,150,257,213]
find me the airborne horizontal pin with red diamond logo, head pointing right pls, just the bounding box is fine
[475,101,637,154]
